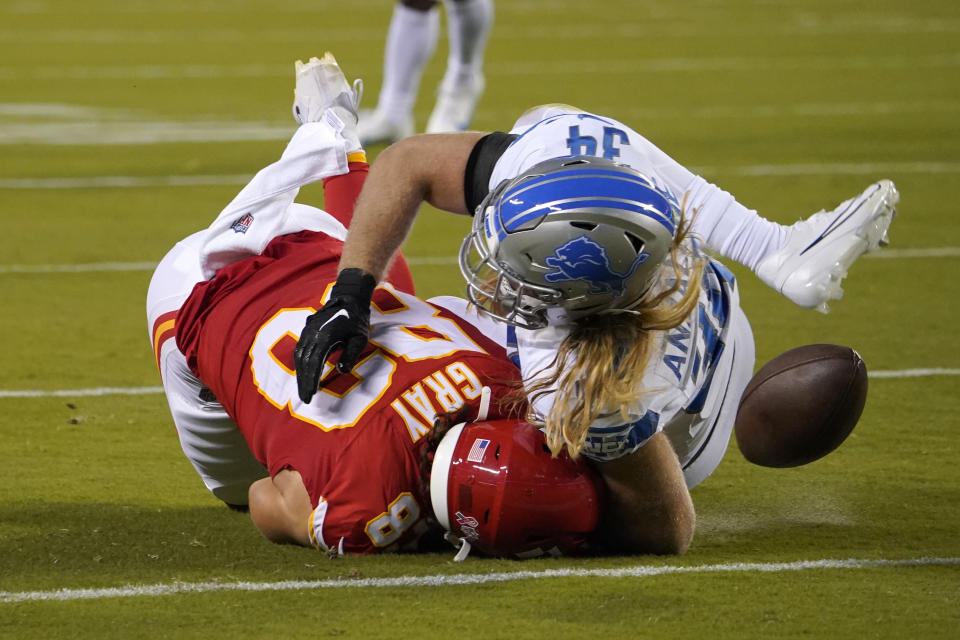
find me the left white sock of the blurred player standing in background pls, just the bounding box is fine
[377,2,440,122]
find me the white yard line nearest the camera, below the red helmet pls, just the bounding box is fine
[0,557,960,603]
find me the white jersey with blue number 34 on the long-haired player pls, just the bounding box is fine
[489,105,754,486]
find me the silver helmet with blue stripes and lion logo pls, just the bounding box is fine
[460,156,680,329]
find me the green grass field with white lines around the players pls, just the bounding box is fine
[0,0,960,640]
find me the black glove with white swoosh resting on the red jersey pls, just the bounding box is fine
[293,269,377,402]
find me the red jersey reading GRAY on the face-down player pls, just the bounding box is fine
[177,232,520,553]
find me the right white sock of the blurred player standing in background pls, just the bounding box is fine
[441,0,493,87]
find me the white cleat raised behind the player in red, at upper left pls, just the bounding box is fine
[293,51,363,150]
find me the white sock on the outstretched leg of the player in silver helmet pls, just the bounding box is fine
[690,178,790,271]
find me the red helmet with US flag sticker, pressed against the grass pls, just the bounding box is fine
[430,420,603,558]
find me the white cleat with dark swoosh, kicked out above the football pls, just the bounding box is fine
[757,180,900,313]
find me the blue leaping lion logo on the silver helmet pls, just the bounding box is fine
[543,235,650,296]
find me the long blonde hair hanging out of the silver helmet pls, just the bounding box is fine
[527,212,706,458]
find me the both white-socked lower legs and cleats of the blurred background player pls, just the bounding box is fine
[358,0,493,145]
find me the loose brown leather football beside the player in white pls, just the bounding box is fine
[734,344,867,467]
